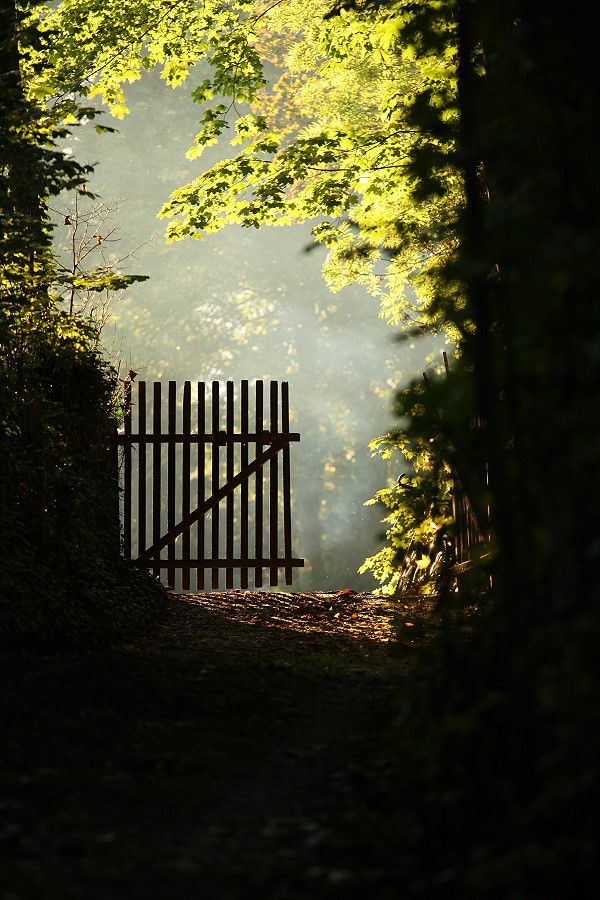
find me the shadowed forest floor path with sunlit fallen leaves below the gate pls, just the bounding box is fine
[0,591,431,900]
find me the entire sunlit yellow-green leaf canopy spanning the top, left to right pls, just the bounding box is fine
[33,0,462,328]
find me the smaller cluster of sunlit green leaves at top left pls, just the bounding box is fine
[31,0,263,118]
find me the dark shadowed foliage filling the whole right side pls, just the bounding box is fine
[360,0,600,900]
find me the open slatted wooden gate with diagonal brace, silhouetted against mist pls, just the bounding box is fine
[117,381,304,591]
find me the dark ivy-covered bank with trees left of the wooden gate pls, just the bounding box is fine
[0,0,164,648]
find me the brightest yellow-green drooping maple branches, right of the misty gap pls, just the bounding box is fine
[156,0,462,336]
